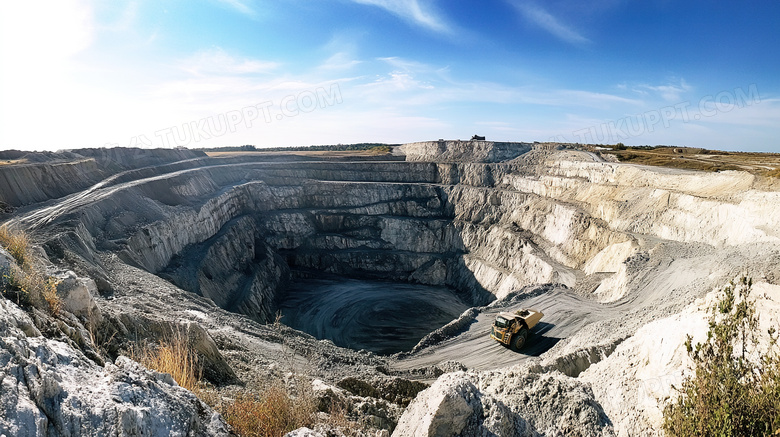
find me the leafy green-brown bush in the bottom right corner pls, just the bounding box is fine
[664,278,780,436]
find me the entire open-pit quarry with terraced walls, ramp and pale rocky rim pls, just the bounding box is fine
[0,141,780,436]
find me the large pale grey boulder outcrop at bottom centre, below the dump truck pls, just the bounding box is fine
[393,367,612,437]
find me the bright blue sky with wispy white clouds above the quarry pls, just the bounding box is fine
[0,0,780,152]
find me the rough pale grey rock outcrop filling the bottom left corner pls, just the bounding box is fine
[0,292,228,437]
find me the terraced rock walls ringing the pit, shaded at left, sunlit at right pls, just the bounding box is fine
[11,141,778,320]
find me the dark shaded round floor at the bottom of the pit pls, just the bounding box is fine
[280,278,469,355]
